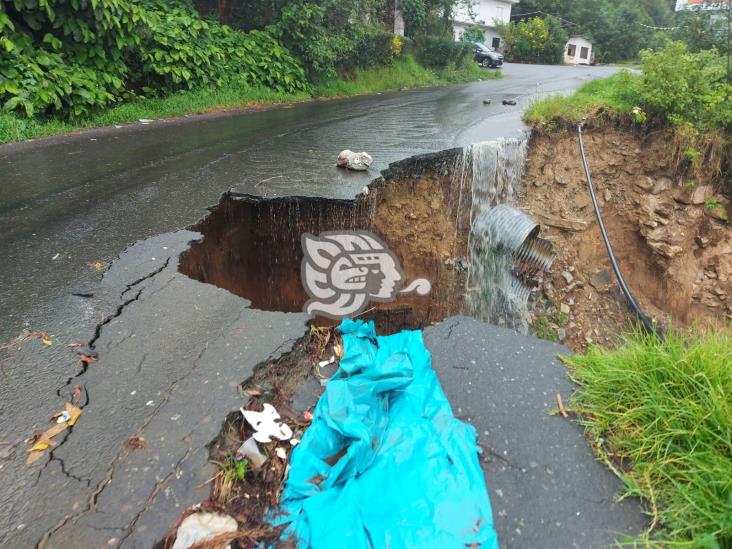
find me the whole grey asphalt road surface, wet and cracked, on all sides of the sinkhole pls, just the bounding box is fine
[0,62,643,548]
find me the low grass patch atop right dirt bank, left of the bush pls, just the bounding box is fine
[524,72,638,130]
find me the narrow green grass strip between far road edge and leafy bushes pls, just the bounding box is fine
[0,56,500,143]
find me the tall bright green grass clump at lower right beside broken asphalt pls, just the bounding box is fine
[565,329,732,549]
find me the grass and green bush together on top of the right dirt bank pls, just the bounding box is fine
[525,42,732,189]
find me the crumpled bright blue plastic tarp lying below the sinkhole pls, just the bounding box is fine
[272,320,498,549]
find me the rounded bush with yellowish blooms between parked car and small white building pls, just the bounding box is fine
[498,17,567,65]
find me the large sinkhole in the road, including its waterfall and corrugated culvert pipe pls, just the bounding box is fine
[179,140,552,333]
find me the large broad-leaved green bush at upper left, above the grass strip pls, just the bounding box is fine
[0,0,306,117]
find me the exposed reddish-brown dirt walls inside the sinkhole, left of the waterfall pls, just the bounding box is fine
[180,150,470,333]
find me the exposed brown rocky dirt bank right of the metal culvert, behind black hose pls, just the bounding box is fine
[520,129,732,350]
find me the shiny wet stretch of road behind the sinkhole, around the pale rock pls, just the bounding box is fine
[0,65,615,341]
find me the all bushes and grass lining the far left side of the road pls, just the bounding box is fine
[0,0,499,142]
